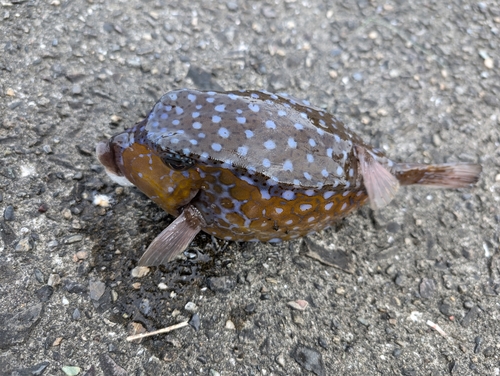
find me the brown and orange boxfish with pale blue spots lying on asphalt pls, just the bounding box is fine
[96,89,482,266]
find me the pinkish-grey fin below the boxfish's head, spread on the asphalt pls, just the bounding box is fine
[139,205,206,266]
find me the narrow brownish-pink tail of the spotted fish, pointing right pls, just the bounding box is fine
[392,163,482,188]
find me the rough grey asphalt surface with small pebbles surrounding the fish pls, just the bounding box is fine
[0,0,500,375]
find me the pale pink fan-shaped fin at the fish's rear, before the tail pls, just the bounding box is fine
[355,146,399,209]
